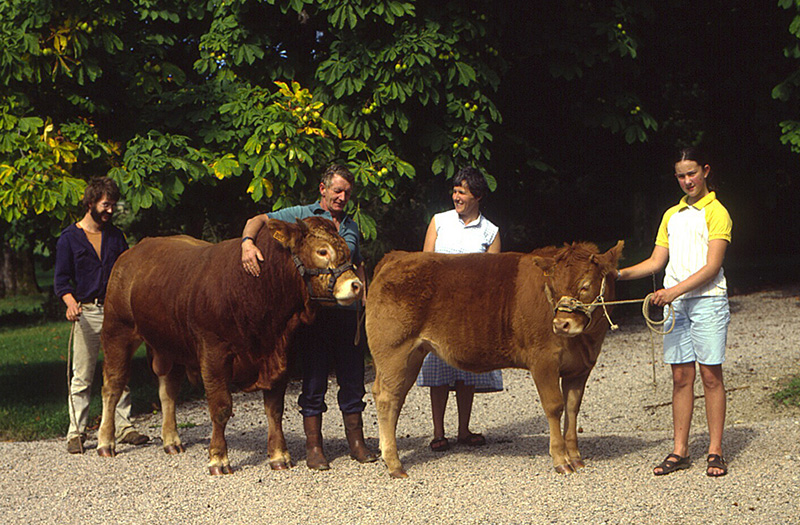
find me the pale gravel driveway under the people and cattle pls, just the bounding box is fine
[0,287,800,525]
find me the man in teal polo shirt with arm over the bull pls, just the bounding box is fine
[242,164,378,470]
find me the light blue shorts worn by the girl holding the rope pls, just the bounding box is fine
[664,296,731,365]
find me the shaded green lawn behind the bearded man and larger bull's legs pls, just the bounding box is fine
[0,296,202,441]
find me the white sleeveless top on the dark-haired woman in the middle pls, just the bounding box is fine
[433,210,498,253]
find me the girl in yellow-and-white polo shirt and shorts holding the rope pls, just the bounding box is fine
[617,148,732,476]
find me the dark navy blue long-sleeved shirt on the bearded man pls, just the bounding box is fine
[53,224,128,303]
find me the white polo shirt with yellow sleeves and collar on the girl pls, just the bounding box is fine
[656,191,733,297]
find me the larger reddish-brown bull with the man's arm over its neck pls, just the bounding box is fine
[98,217,363,474]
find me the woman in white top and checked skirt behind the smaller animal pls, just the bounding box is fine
[417,167,503,452]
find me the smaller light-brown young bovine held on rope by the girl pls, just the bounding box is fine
[366,241,623,477]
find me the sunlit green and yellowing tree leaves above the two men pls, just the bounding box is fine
[0,0,656,242]
